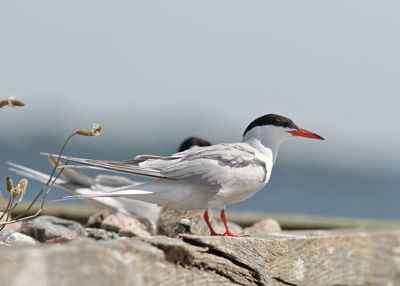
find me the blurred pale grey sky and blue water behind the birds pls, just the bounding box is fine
[0,0,400,219]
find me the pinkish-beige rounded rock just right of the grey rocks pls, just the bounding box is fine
[101,213,151,237]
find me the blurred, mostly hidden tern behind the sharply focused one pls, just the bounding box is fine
[7,137,211,224]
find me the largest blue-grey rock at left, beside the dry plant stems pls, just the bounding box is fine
[21,216,86,242]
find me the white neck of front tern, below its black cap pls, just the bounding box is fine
[242,128,284,164]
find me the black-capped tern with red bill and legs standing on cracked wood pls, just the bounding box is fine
[44,114,323,236]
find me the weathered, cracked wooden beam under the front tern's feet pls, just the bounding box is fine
[0,229,400,286]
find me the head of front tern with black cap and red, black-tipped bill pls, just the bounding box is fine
[243,114,325,145]
